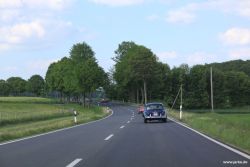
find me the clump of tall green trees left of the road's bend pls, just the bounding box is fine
[45,42,108,106]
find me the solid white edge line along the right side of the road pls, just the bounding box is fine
[168,117,250,159]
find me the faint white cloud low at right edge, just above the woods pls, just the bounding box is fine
[229,48,250,60]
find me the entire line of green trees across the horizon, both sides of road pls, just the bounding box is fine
[0,41,250,109]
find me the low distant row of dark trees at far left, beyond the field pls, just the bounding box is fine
[0,75,45,96]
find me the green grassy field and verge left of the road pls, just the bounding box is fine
[0,97,108,142]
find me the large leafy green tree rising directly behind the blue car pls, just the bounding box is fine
[114,42,157,103]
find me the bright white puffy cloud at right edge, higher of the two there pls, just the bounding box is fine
[219,28,250,45]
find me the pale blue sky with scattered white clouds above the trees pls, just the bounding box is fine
[0,0,250,80]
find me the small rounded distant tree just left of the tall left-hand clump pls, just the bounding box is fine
[27,75,45,96]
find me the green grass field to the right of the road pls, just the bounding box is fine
[169,106,250,153]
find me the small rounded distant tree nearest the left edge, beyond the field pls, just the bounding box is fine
[7,77,27,96]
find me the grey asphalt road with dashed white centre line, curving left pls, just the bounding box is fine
[0,105,250,167]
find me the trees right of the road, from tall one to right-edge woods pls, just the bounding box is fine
[109,42,250,108]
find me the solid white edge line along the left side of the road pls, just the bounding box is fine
[0,110,114,146]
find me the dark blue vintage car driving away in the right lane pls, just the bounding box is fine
[143,103,167,123]
